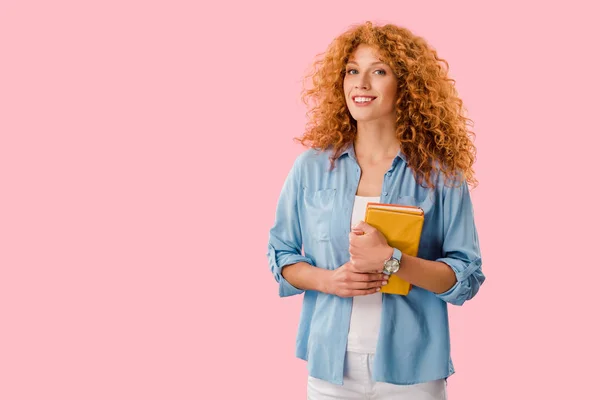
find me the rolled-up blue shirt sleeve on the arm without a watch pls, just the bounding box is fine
[267,159,313,297]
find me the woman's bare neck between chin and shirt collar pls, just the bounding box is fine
[354,120,400,163]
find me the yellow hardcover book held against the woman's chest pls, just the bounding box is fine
[365,203,425,295]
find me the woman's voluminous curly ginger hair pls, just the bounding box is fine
[294,21,477,187]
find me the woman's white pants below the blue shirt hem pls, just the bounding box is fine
[307,351,446,400]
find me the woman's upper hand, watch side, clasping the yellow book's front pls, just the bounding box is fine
[350,221,394,272]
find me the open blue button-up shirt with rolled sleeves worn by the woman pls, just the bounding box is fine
[267,145,485,385]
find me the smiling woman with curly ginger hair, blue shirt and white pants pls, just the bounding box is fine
[268,22,485,399]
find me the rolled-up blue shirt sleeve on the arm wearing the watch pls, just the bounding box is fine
[436,178,485,306]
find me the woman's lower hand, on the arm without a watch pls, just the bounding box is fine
[325,261,387,297]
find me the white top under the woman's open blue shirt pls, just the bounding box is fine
[347,196,382,354]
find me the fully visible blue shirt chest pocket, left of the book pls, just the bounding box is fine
[304,189,336,241]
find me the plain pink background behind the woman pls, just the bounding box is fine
[0,0,600,400]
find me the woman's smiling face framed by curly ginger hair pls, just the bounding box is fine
[344,44,398,121]
